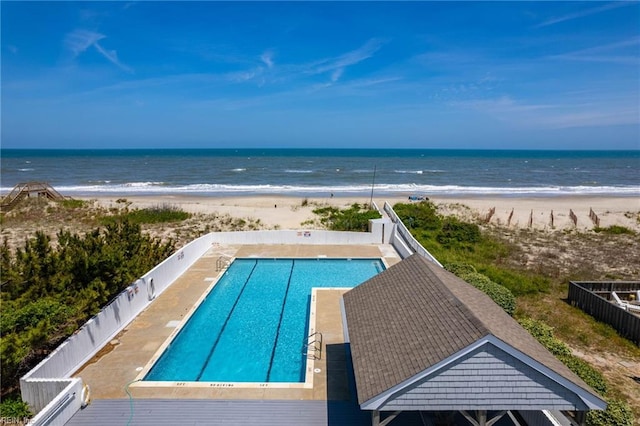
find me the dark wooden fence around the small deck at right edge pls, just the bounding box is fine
[568,281,640,346]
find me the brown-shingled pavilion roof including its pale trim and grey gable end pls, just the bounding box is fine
[343,255,606,410]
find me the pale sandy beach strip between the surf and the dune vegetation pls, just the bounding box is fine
[87,195,640,231]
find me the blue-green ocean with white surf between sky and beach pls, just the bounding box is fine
[0,149,640,197]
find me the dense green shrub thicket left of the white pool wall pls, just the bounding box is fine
[0,220,174,393]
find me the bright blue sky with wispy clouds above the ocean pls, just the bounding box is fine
[0,1,640,149]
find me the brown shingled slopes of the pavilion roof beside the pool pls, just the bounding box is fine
[344,255,604,404]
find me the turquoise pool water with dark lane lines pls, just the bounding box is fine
[144,259,384,383]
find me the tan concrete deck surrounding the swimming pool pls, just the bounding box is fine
[74,245,400,400]
